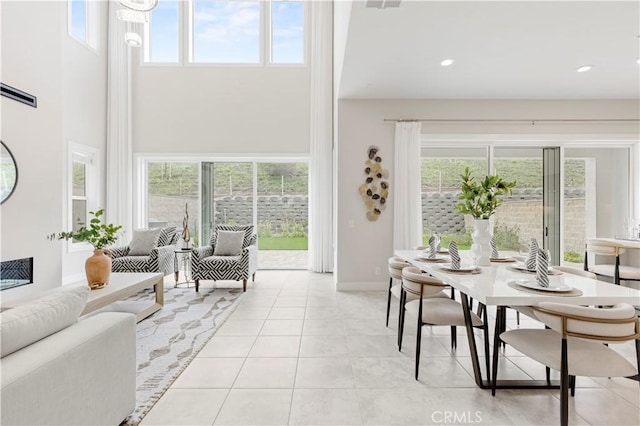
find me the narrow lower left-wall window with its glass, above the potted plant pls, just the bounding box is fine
[68,142,99,250]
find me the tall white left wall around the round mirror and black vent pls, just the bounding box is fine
[0,1,106,301]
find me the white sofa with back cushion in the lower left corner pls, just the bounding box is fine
[0,287,136,425]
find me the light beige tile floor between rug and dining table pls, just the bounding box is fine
[142,271,640,425]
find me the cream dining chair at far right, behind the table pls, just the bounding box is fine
[584,238,640,285]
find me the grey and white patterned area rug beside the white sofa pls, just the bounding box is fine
[121,287,243,426]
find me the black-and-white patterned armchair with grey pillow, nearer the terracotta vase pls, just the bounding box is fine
[110,226,178,276]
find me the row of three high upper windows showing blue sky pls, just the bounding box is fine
[144,0,306,65]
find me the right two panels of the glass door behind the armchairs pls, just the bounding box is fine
[200,161,309,269]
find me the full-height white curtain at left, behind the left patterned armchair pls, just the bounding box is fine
[105,1,133,242]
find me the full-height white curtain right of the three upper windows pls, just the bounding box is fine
[308,1,333,272]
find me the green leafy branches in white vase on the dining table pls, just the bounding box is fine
[456,167,516,219]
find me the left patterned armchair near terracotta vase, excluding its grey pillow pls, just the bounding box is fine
[109,226,178,276]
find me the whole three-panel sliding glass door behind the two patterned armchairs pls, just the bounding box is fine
[137,158,309,269]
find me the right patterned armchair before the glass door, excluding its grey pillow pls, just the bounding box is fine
[191,225,258,291]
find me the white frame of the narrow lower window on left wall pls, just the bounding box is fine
[65,141,100,253]
